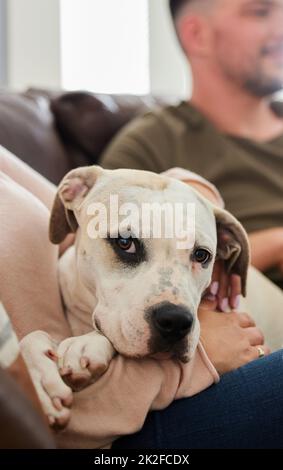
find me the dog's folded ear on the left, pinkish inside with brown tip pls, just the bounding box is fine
[49,166,103,244]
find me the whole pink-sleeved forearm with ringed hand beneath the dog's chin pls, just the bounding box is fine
[54,305,269,448]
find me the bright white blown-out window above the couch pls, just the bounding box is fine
[60,0,150,94]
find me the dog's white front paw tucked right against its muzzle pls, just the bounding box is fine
[57,331,115,391]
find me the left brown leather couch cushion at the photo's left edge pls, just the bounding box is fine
[0,91,71,183]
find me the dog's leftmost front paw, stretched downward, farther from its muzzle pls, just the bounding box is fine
[20,331,73,428]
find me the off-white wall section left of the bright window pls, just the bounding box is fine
[7,0,60,89]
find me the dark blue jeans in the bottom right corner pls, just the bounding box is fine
[112,350,283,449]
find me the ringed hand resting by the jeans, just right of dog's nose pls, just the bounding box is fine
[198,303,270,375]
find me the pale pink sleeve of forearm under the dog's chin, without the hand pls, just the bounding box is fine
[56,346,217,448]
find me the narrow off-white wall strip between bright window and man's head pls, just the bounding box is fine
[149,0,191,98]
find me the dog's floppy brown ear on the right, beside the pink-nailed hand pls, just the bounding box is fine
[214,207,250,296]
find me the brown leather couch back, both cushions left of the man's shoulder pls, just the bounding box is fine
[0,89,171,183]
